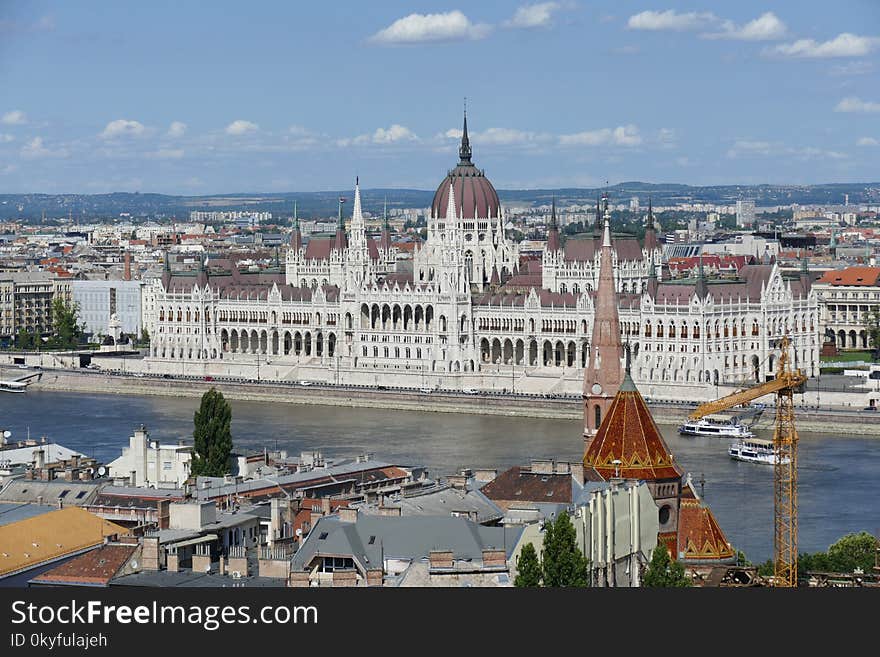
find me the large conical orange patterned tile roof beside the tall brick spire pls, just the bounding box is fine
[584,374,683,481]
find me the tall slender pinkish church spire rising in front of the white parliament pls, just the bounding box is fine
[584,207,623,451]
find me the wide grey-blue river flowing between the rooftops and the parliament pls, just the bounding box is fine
[0,390,880,561]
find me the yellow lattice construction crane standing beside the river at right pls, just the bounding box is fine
[690,337,807,586]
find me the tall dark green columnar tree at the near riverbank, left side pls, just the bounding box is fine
[190,388,232,477]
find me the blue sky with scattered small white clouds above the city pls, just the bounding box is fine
[0,0,880,195]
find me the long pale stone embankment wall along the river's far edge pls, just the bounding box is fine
[17,370,880,437]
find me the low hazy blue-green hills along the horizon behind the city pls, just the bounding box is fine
[0,182,880,221]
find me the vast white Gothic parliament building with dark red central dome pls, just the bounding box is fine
[144,118,821,398]
